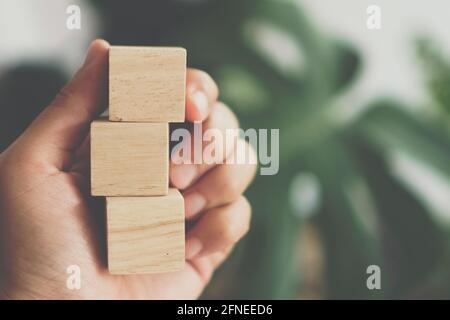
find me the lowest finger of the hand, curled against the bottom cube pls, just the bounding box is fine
[186,197,251,260]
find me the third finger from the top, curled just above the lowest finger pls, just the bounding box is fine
[183,140,256,219]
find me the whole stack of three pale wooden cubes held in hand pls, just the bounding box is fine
[91,46,186,274]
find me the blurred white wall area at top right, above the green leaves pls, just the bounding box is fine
[296,0,450,115]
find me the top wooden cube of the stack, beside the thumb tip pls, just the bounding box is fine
[109,46,186,122]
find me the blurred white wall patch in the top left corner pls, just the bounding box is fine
[0,0,99,73]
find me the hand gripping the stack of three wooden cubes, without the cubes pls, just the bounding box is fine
[0,40,256,299]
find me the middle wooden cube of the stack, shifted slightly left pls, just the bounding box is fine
[91,120,169,196]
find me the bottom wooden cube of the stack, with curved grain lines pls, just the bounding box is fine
[106,189,185,274]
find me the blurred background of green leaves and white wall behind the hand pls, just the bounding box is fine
[0,0,450,299]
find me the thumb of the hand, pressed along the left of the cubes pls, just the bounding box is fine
[19,40,109,169]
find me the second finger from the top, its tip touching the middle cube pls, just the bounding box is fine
[169,102,239,190]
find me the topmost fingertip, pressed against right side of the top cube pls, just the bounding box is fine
[186,69,219,122]
